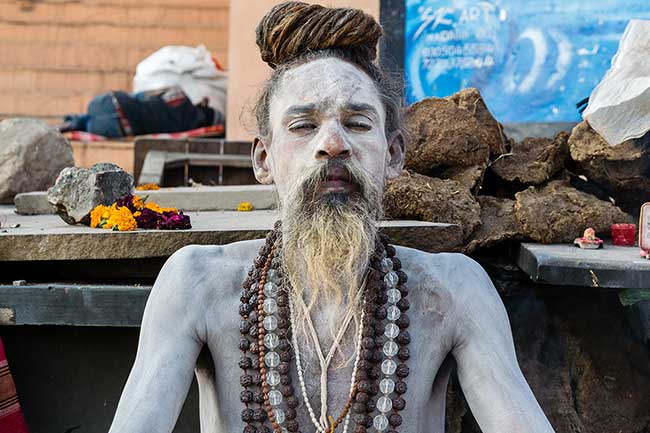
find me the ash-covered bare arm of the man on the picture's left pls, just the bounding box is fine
[109,247,204,433]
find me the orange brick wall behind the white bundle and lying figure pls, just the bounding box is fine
[0,0,229,122]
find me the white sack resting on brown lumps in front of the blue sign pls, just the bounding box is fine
[582,20,650,146]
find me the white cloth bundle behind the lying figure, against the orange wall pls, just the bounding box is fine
[133,45,228,117]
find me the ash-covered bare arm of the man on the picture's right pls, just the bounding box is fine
[452,258,554,433]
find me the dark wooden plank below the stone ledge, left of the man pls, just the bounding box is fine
[0,284,151,327]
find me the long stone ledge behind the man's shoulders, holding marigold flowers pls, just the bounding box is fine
[0,206,462,262]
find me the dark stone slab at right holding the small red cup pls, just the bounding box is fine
[517,243,650,289]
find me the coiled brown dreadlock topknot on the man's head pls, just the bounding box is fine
[256,1,382,69]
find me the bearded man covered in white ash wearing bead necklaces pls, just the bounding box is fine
[110,2,553,433]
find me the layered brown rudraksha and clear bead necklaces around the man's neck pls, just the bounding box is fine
[239,222,410,433]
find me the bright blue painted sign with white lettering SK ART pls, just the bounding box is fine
[404,0,650,122]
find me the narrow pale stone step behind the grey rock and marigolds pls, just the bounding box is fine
[14,185,276,215]
